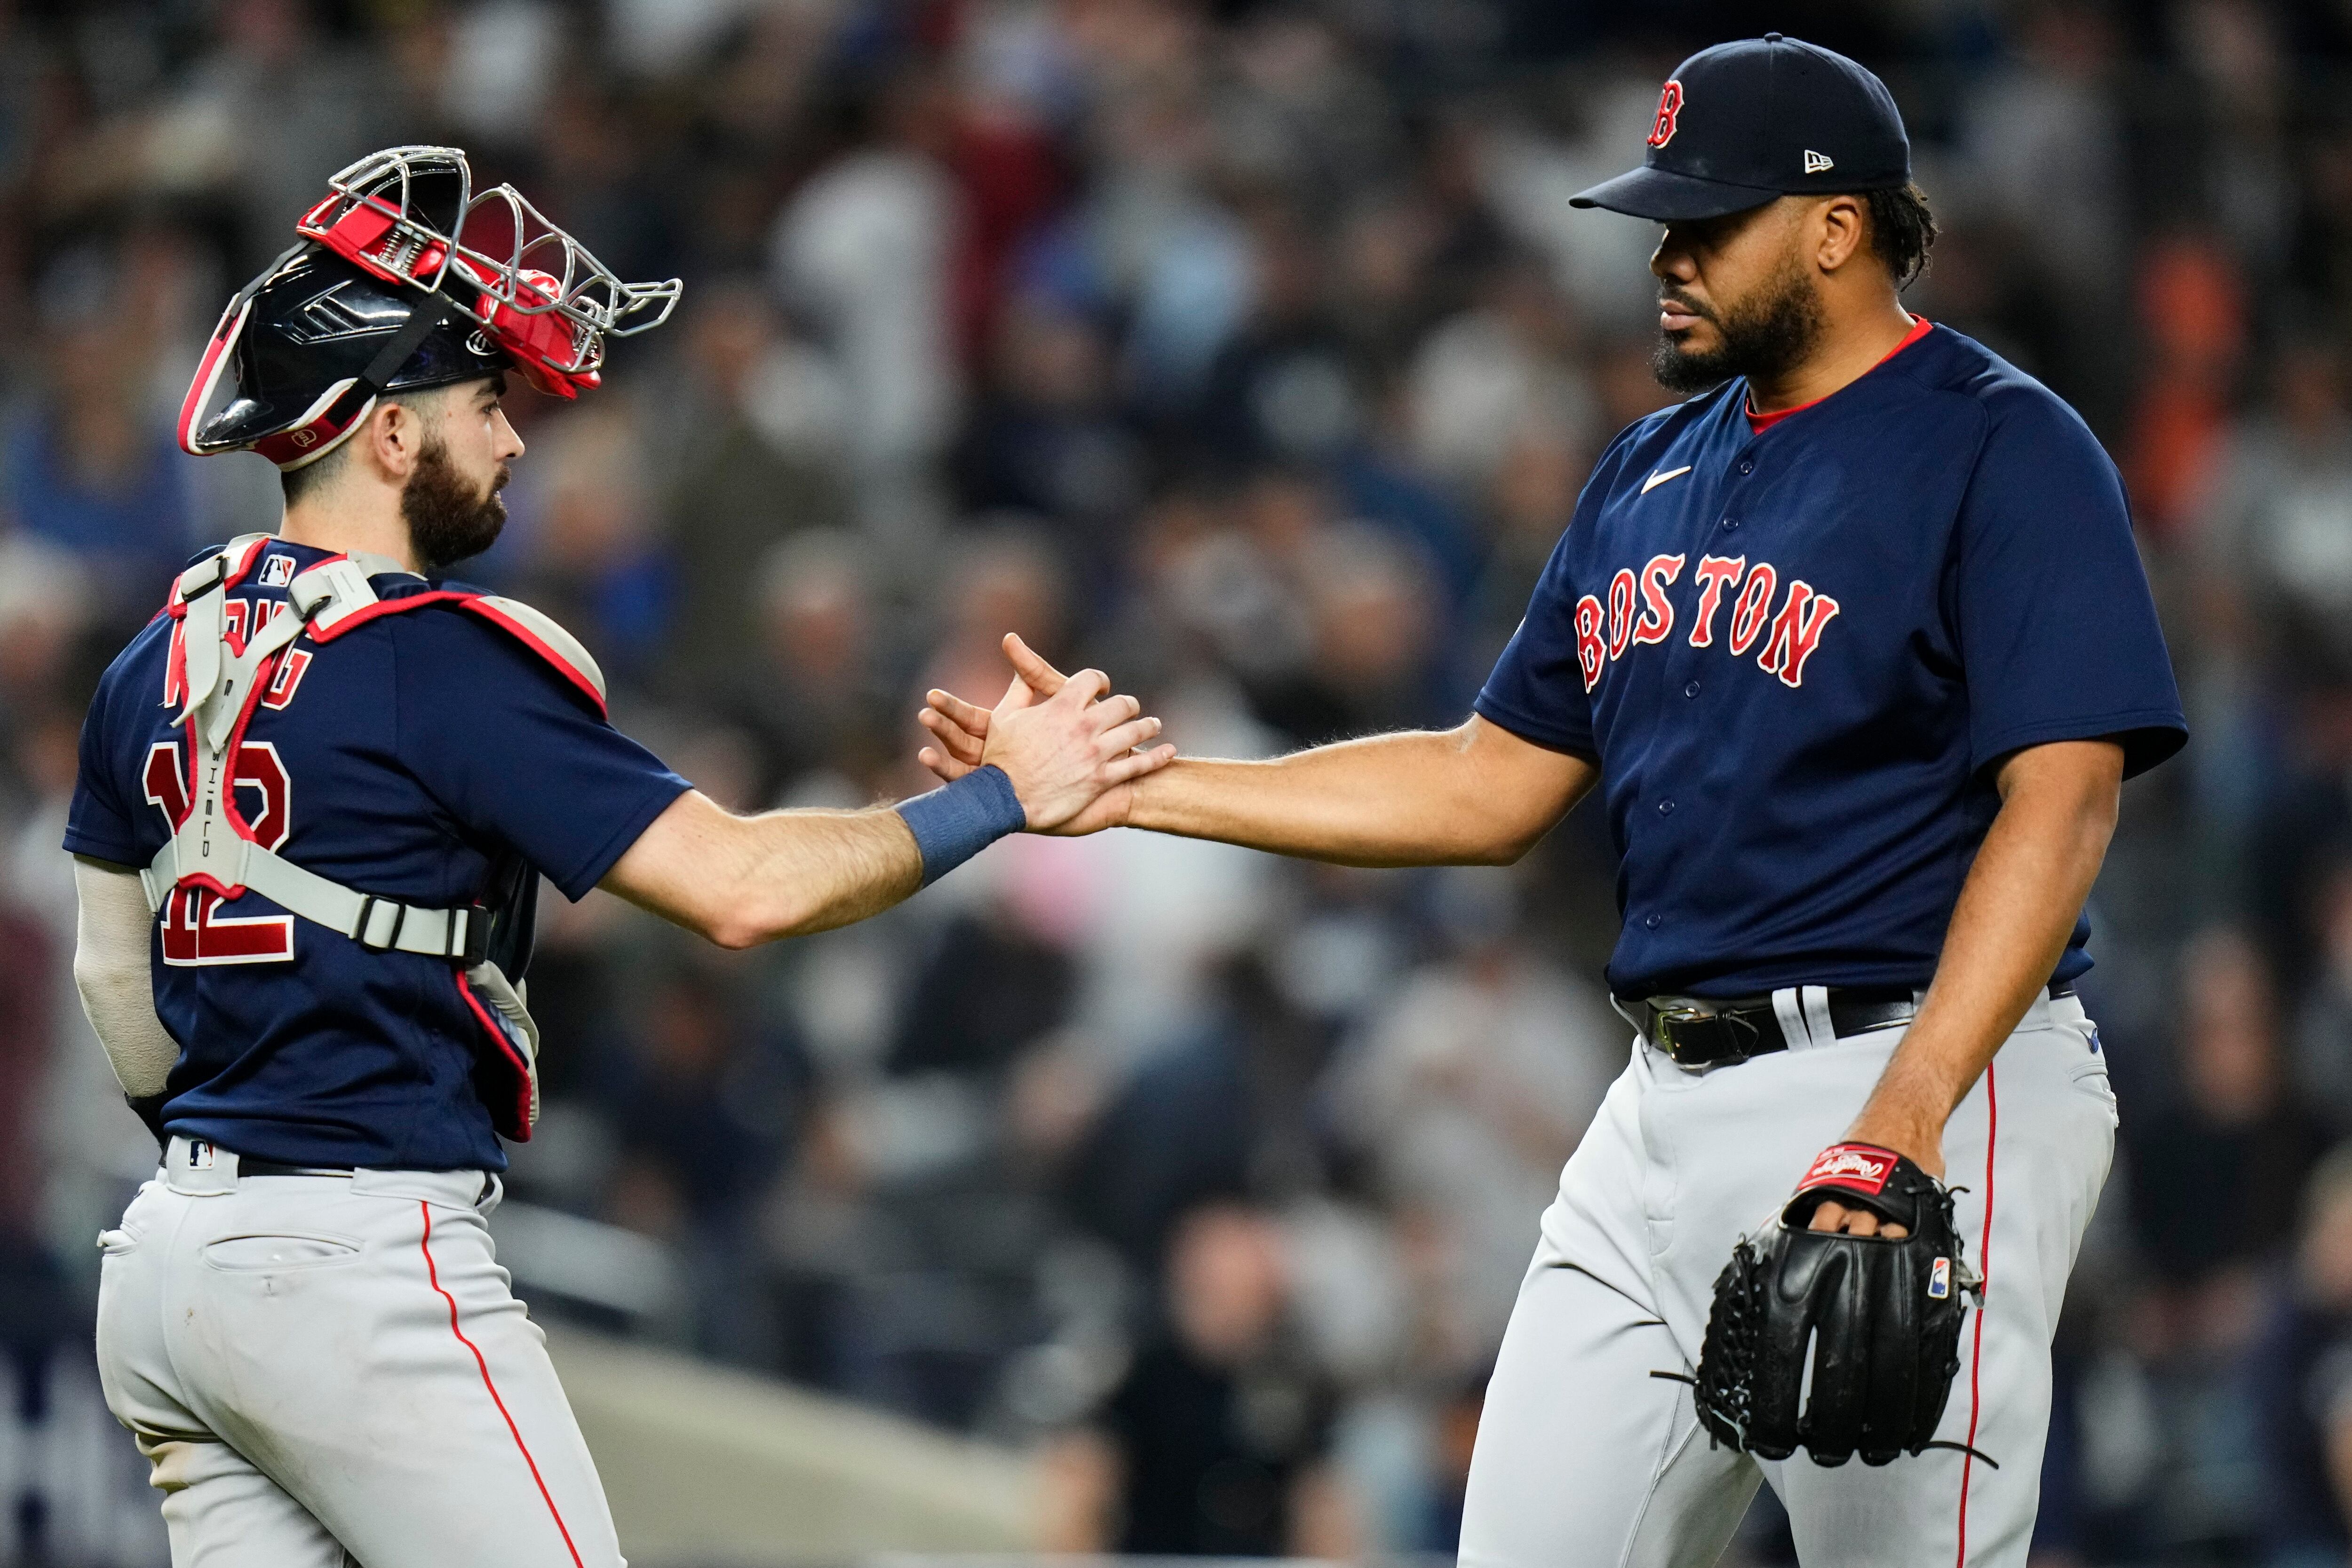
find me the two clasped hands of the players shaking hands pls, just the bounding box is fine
[917,635,1176,834]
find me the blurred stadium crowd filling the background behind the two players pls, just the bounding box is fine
[0,0,2352,1568]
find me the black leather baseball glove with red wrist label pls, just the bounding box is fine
[1696,1142,1990,1465]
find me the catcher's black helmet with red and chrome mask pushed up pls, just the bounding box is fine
[179,146,680,470]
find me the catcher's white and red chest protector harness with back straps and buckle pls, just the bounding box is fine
[139,534,604,1142]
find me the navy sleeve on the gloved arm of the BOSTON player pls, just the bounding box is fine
[1952,386,2187,776]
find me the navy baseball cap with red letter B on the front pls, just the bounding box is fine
[1569,33,1910,223]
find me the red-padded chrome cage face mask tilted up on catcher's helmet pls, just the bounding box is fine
[294,146,682,397]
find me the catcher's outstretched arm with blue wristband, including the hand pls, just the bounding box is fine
[602,670,1176,947]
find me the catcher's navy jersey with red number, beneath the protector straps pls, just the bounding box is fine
[66,543,687,1171]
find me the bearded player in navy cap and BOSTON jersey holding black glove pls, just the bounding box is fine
[924,33,2185,1568]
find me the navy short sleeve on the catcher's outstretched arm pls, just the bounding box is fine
[393,611,691,898]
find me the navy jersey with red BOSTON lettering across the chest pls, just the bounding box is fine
[1477,327,2187,997]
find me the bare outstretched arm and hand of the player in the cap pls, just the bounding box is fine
[922,637,1599,865]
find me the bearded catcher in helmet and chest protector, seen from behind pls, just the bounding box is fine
[66,148,1167,1568]
